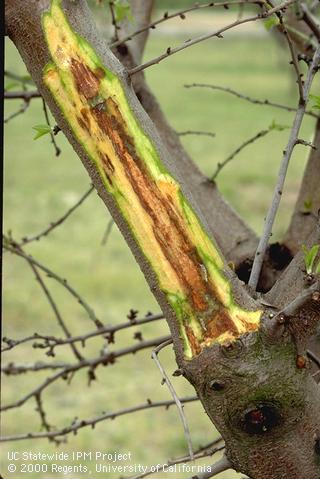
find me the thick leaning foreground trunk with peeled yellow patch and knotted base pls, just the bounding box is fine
[6,0,320,479]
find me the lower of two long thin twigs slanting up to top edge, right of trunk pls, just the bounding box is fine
[128,0,296,75]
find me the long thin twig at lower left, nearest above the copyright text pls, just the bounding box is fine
[0,396,198,442]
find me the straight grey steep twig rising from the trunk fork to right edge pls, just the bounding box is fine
[249,46,320,290]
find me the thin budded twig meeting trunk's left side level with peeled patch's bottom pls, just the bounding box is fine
[0,336,170,411]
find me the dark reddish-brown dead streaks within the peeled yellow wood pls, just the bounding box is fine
[72,59,237,348]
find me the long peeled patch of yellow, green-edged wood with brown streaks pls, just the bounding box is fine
[43,0,261,359]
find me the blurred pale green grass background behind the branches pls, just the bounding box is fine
[1,0,319,479]
